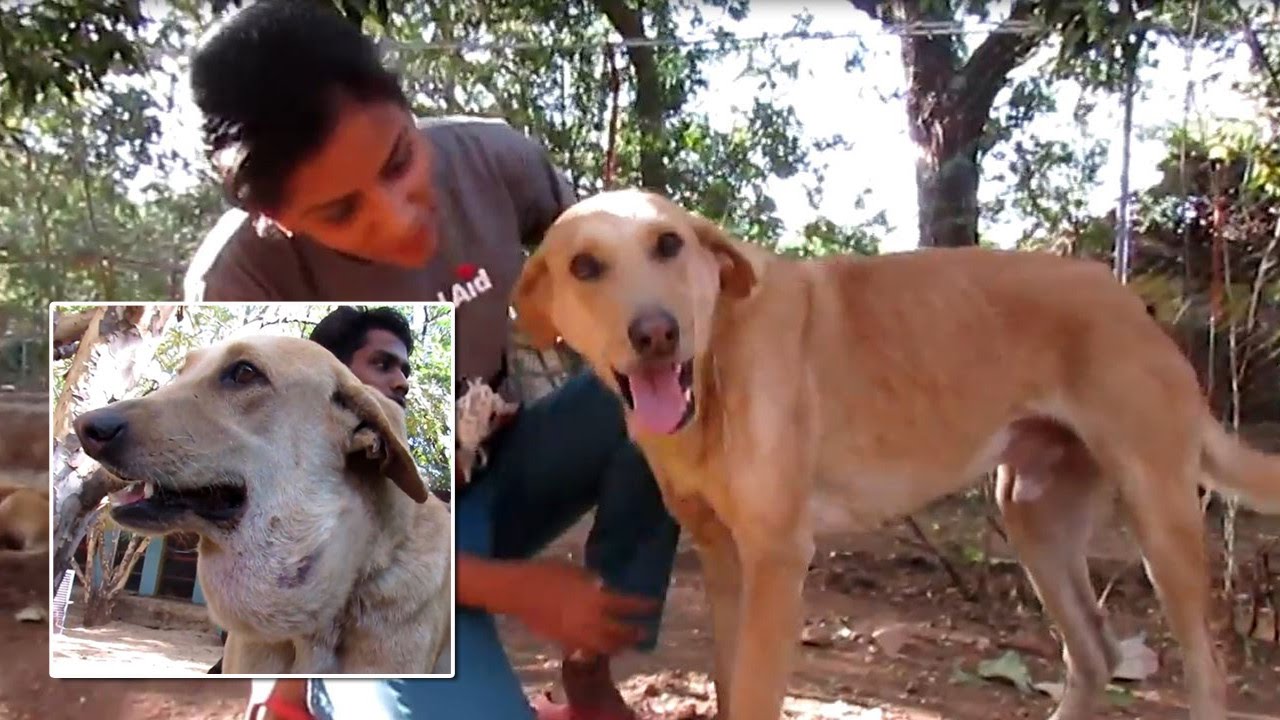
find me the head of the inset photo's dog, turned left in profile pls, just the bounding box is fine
[74,336,428,539]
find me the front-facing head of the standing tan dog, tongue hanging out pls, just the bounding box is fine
[513,191,756,434]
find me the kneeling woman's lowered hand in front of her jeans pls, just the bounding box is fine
[509,560,658,655]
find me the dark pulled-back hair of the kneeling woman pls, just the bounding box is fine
[191,0,410,211]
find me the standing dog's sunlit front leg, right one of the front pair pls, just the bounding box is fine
[730,525,814,720]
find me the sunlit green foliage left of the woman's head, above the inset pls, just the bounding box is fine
[0,5,220,313]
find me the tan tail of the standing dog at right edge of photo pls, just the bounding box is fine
[1201,413,1280,515]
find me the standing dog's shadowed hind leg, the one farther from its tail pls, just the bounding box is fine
[996,458,1119,720]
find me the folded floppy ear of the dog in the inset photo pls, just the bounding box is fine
[334,368,429,502]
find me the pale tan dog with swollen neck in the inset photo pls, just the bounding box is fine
[74,336,453,674]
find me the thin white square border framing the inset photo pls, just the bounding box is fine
[45,300,458,680]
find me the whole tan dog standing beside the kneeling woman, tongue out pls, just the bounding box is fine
[515,191,1280,720]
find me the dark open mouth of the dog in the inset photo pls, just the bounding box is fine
[110,471,248,529]
